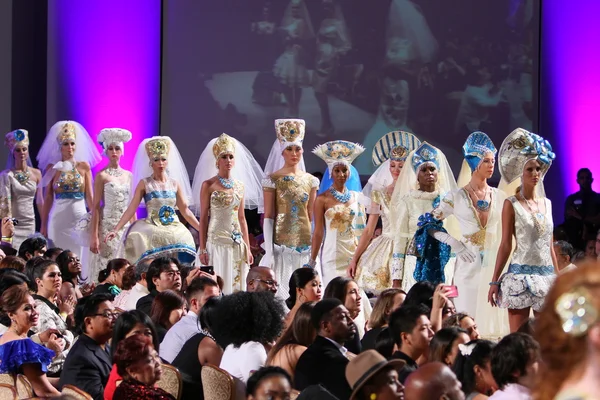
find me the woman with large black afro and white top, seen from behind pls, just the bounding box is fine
[212,292,285,383]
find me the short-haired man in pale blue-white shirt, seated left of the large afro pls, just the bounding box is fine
[160,276,221,363]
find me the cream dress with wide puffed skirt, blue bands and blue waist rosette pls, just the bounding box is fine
[124,177,196,264]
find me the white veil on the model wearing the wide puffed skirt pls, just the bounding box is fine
[131,136,193,207]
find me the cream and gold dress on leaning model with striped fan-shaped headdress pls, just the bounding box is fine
[356,190,394,294]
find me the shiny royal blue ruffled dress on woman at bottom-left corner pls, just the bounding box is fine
[0,338,54,374]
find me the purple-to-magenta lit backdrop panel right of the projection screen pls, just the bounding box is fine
[540,0,600,194]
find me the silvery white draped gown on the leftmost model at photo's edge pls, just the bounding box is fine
[0,170,37,250]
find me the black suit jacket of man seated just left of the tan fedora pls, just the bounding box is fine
[294,336,352,399]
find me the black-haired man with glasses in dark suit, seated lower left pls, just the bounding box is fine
[58,293,118,400]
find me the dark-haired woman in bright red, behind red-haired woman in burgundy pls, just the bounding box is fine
[104,310,160,400]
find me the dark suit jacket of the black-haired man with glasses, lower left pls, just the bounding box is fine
[58,334,112,400]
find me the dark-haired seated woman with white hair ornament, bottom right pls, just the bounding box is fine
[452,339,498,400]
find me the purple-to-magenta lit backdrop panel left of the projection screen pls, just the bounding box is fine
[48,0,161,169]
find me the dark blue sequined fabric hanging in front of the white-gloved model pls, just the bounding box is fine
[413,213,451,285]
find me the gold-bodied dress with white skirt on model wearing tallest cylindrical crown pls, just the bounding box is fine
[262,173,319,293]
